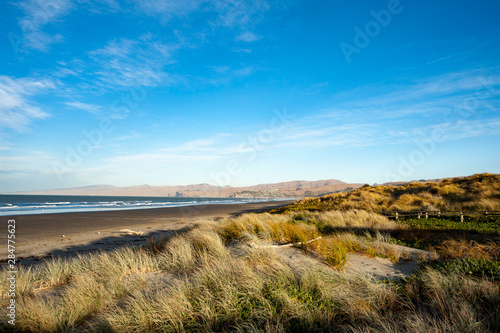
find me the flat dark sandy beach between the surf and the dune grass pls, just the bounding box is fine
[0,200,292,264]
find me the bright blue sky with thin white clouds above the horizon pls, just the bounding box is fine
[0,0,500,193]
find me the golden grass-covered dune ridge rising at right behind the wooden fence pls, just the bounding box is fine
[276,173,500,212]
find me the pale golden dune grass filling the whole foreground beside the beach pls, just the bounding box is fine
[0,210,500,332]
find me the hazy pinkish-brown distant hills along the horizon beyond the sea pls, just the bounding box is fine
[11,179,362,198]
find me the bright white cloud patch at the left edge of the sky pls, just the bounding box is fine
[0,76,56,131]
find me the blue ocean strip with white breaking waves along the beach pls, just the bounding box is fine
[0,194,283,216]
